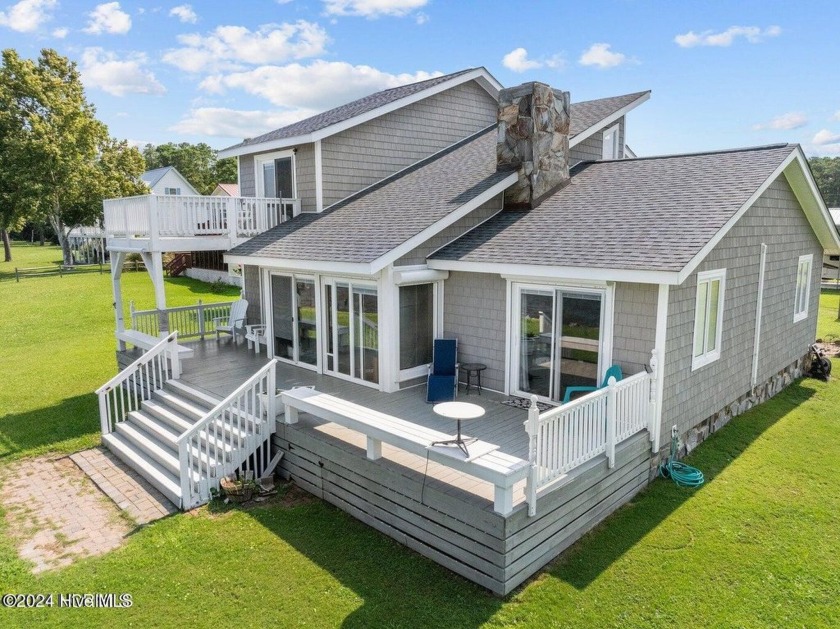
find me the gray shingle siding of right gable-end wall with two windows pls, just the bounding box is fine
[660,176,822,445]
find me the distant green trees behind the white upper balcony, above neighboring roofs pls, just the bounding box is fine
[143,142,236,194]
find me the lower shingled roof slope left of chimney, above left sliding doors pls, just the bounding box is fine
[229,126,510,263]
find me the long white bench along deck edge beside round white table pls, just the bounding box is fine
[281,388,529,515]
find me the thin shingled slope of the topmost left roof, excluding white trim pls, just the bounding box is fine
[220,68,475,150]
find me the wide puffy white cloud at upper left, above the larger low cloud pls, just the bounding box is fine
[163,20,329,72]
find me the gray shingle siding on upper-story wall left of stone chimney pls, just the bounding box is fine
[321,81,497,207]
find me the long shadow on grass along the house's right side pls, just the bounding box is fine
[547,381,815,590]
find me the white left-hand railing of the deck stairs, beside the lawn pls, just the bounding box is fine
[96,331,181,435]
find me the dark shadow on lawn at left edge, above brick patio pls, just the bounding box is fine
[0,393,99,462]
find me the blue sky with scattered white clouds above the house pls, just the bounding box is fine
[0,0,840,155]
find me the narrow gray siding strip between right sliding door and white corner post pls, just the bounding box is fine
[613,282,659,374]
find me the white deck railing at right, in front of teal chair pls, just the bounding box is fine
[525,372,655,516]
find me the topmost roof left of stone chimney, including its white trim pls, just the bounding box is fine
[218,67,502,157]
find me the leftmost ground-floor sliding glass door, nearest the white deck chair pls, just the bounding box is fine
[271,275,318,367]
